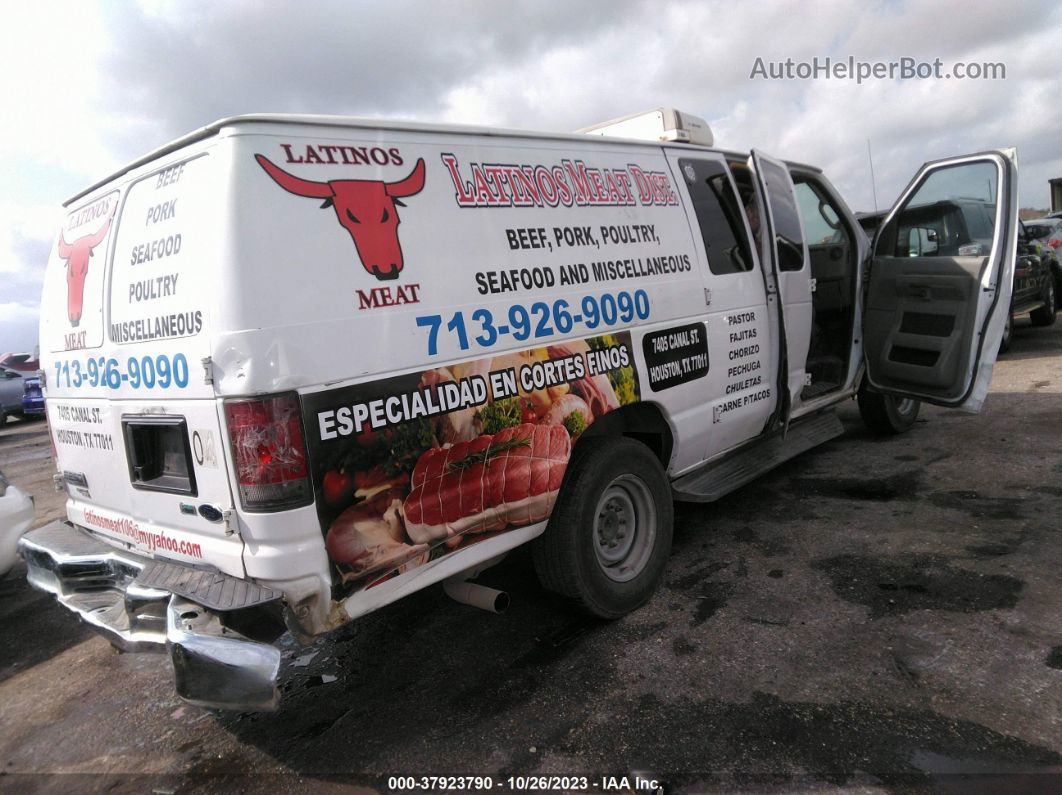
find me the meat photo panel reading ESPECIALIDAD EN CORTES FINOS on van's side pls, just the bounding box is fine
[303,332,639,590]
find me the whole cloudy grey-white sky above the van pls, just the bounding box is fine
[0,0,1062,351]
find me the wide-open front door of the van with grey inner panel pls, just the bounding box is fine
[863,150,1017,412]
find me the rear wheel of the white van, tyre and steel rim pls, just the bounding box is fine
[533,436,674,619]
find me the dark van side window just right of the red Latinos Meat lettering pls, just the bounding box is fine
[679,158,752,275]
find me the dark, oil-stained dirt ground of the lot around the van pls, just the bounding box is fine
[0,321,1062,792]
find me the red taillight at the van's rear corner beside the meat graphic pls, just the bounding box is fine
[225,393,313,511]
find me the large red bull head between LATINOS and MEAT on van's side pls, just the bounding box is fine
[255,155,424,281]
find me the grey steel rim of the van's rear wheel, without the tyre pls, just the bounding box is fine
[594,474,656,583]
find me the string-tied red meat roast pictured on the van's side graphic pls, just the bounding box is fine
[402,422,571,543]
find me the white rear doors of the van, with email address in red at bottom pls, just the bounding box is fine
[40,150,243,576]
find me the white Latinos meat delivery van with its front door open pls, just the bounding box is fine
[21,109,1017,709]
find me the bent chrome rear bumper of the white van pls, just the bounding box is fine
[19,521,280,710]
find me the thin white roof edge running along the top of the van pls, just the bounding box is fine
[63,114,821,207]
